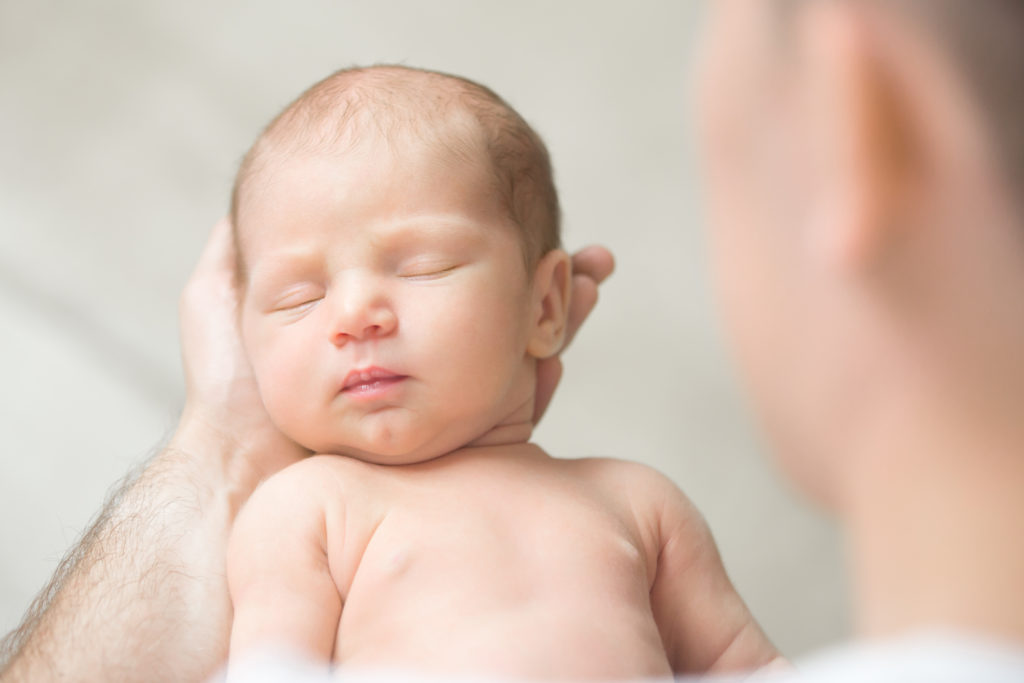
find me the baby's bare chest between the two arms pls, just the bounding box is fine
[311,459,668,678]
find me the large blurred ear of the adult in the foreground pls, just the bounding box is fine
[800,2,912,270]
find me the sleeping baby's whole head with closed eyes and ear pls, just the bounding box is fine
[231,67,570,464]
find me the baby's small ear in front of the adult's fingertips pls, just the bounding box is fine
[526,249,572,358]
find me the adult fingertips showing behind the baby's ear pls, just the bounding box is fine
[534,245,615,425]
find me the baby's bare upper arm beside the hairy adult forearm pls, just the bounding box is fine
[227,461,342,661]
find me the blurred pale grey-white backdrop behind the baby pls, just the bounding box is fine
[0,0,848,655]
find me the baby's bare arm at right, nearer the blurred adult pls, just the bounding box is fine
[648,475,781,674]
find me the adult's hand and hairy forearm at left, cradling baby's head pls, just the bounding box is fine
[0,221,305,683]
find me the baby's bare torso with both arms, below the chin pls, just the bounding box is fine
[229,443,775,679]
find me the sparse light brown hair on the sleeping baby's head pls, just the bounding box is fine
[230,65,561,278]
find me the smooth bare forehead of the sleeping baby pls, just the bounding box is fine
[236,141,524,274]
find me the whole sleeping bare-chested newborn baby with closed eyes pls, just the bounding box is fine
[227,67,776,679]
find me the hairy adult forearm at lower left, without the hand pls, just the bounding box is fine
[0,434,255,683]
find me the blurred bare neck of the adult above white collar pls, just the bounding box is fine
[841,362,1024,645]
